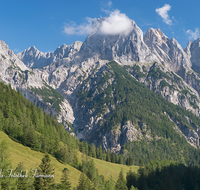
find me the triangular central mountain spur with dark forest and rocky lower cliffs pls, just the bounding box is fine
[76,62,200,164]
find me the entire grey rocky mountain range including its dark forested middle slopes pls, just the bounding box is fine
[0,18,200,156]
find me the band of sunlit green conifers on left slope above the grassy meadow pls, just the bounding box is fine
[0,82,133,169]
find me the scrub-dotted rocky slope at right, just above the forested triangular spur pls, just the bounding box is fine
[131,63,200,116]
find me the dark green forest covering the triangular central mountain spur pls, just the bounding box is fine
[77,61,200,166]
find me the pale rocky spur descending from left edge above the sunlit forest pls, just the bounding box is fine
[0,40,73,132]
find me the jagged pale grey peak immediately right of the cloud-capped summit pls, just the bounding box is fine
[144,28,191,73]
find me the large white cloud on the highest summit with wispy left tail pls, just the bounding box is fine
[63,10,133,35]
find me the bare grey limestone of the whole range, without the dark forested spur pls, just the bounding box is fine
[0,18,200,152]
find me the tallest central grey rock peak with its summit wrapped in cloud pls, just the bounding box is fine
[80,18,158,64]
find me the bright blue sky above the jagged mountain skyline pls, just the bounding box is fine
[0,0,200,53]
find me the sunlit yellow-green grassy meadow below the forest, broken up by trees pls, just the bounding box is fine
[0,131,139,187]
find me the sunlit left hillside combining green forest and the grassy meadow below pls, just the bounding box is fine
[0,83,140,189]
